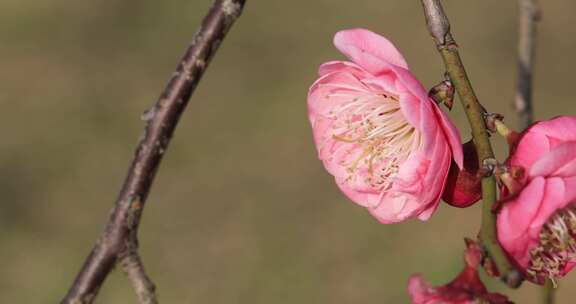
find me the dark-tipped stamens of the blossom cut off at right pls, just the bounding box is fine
[527,204,576,284]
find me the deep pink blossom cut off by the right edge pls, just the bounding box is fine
[497,116,576,284]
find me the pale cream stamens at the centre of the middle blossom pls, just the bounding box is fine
[330,92,422,191]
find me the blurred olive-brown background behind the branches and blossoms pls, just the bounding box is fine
[0,0,576,304]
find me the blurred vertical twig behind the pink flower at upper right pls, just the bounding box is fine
[514,0,540,130]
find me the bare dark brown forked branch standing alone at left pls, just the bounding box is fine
[61,0,245,304]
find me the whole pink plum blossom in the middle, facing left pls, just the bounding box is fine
[308,29,463,223]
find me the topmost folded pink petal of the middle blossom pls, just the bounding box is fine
[334,28,408,73]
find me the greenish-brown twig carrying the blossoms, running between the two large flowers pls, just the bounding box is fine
[421,0,522,287]
